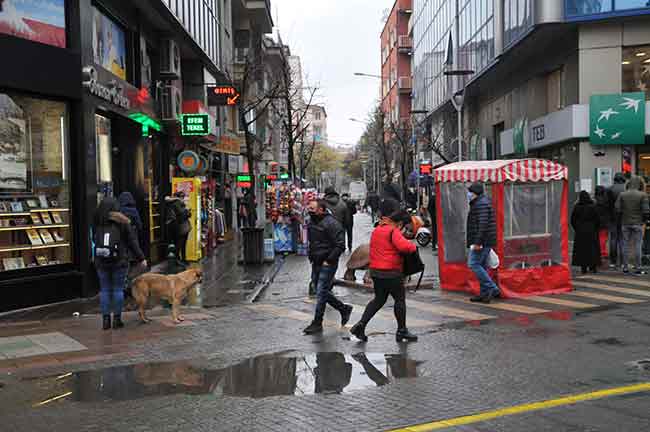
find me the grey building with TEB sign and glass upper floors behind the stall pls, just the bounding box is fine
[409,0,650,200]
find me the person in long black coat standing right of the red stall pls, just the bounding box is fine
[571,191,600,274]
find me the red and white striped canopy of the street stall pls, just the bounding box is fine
[434,159,569,183]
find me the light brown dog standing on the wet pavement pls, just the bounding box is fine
[131,268,203,324]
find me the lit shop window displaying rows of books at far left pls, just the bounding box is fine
[0,91,72,272]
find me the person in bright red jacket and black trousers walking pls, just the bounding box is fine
[350,199,418,342]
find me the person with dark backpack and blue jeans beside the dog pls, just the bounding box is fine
[93,197,147,330]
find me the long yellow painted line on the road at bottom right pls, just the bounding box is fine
[384,382,650,432]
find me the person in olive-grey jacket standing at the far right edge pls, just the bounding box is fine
[616,176,650,275]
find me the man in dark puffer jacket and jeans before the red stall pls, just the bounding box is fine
[467,183,501,303]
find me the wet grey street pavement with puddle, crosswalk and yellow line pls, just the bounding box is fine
[0,215,650,431]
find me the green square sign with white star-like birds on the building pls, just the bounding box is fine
[589,92,646,145]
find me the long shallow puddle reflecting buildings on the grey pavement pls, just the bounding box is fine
[24,352,425,407]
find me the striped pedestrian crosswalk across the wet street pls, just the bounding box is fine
[247,273,650,332]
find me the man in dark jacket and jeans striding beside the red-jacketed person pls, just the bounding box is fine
[304,200,352,334]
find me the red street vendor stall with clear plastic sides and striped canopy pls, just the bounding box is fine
[434,159,571,298]
